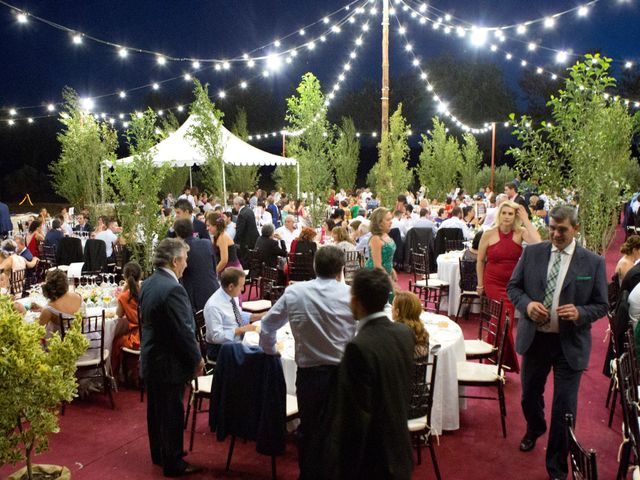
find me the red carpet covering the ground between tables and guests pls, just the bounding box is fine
[0,231,623,480]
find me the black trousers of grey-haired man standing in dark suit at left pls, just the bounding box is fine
[146,380,187,475]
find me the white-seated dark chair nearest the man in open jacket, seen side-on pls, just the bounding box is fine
[457,315,510,438]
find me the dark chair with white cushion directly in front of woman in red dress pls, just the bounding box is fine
[464,296,504,363]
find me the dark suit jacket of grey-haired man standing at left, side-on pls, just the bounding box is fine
[140,269,202,384]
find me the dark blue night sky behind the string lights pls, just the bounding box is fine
[0,0,640,185]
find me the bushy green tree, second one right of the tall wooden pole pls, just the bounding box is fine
[418,117,462,200]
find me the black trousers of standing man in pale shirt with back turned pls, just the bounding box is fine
[296,365,338,479]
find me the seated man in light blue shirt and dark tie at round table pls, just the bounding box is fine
[204,268,264,360]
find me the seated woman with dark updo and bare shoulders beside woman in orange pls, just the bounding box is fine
[31,270,84,338]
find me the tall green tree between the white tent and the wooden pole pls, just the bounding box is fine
[274,73,334,197]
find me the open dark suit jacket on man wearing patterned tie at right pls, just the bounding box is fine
[507,242,608,370]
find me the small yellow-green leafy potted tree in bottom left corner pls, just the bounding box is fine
[0,295,88,480]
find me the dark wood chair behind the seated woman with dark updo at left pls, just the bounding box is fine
[59,310,116,408]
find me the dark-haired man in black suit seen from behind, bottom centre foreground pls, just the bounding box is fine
[309,269,414,480]
